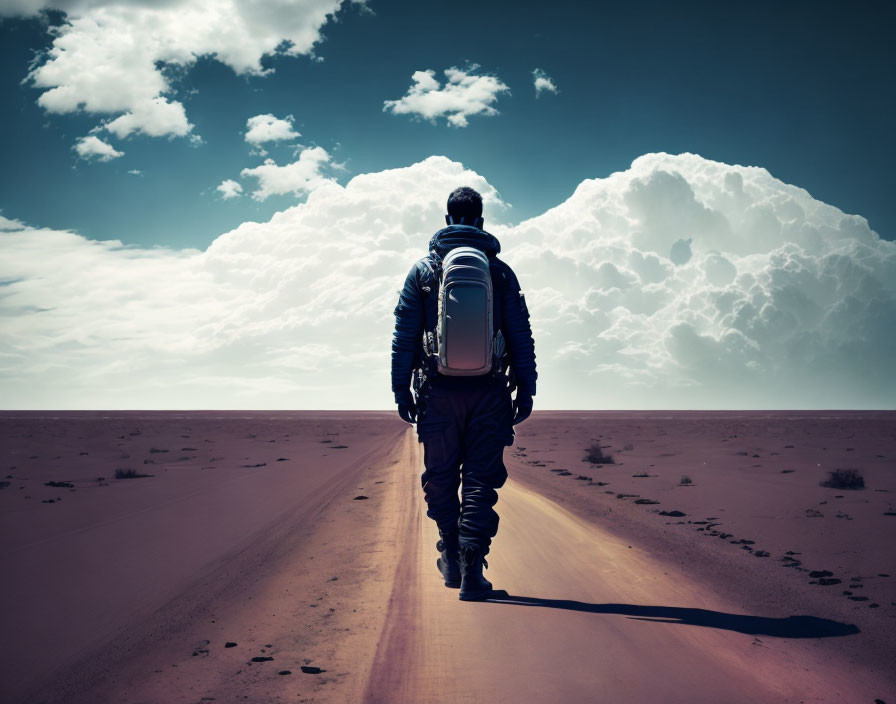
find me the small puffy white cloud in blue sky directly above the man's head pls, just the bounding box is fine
[383,64,510,127]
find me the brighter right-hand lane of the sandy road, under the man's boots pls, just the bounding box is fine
[366,428,888,704]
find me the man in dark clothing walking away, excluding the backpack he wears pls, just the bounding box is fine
[392,187,537,601]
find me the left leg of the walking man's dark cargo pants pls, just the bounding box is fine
[417,388,464,532]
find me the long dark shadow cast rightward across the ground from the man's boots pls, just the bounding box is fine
[485,590,859,638]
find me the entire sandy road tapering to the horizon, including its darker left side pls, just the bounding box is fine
[10,429,893,704]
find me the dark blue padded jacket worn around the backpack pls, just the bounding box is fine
[392,225,538,400]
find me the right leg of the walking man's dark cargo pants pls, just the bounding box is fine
[460,379,513,553]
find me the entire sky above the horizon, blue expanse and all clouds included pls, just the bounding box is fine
[0,0,896,409]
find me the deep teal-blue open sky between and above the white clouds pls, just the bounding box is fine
[0,0,896,248]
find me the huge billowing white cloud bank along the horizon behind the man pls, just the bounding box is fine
[0,154,896,409]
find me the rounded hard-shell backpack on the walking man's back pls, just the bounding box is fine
[435,247,503,376]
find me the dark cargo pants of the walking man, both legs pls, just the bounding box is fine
[417,377,514,554]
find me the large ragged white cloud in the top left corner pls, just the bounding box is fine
[21,0,350,137]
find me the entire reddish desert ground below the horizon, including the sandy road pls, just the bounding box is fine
[0,411,896,704]
